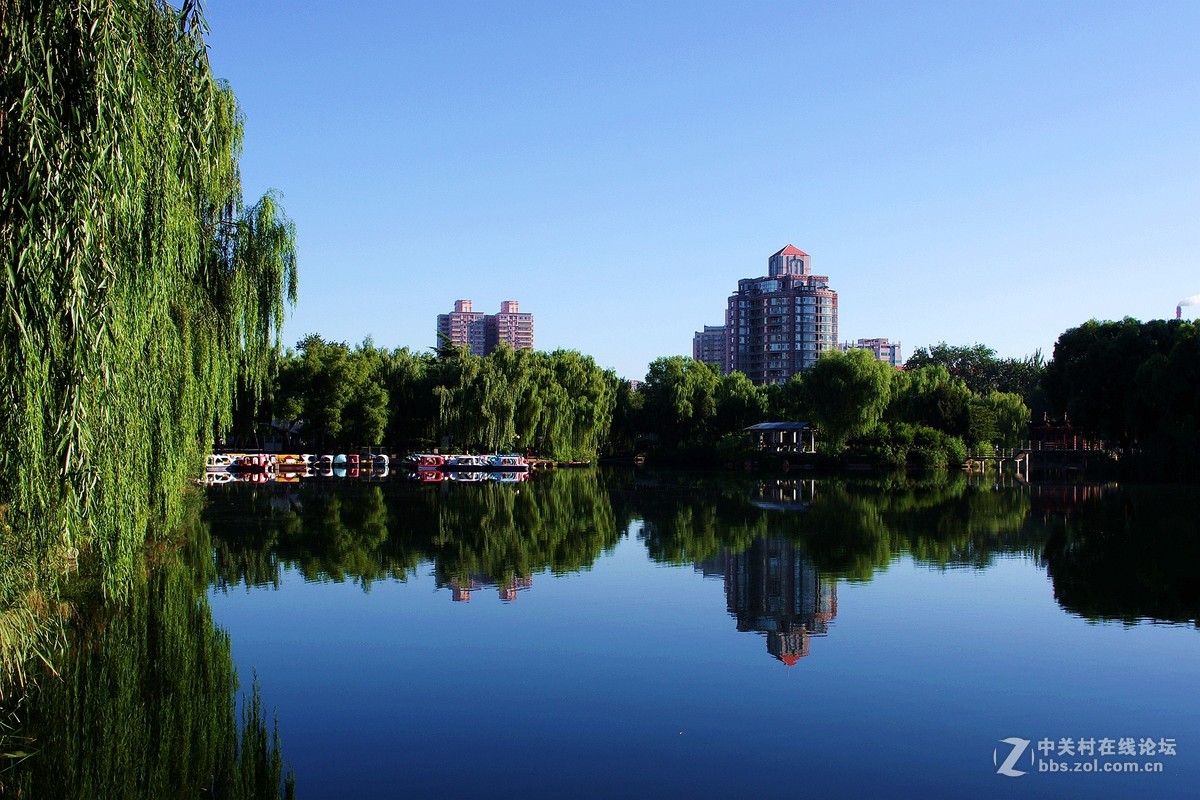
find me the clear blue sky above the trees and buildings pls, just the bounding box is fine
[206,0,1200,378]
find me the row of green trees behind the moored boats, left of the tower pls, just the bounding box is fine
[265,336,620,459]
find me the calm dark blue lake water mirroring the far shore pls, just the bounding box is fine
[9,470,1200,798]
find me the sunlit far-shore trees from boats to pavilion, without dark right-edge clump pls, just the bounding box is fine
[264,335,1030,465]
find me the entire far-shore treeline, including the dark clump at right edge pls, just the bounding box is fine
[243,319,1200,477]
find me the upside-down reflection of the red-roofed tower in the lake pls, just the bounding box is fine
[696,539,838,667]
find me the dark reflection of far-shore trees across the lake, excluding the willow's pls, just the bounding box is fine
[201,470,1198,633]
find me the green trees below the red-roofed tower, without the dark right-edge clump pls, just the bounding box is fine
[628,350,1030,467]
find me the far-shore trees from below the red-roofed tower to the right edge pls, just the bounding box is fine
[614,318,1200,476]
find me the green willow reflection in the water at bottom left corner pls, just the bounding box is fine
[0,501,293,800]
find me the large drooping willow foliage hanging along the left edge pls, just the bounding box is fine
[0,0,296,602]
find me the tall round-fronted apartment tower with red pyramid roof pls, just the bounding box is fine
[725,245,838,384]
